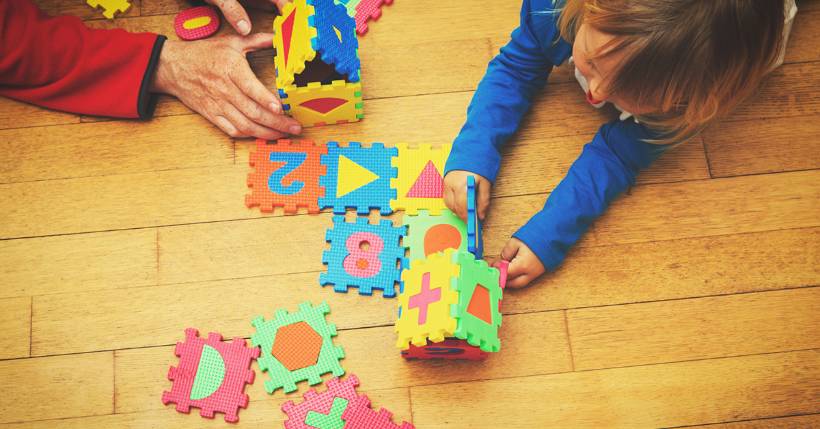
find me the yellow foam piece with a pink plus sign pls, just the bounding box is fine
[395,250,459,350]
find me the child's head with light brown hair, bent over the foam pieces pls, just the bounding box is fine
[559,0,784,142]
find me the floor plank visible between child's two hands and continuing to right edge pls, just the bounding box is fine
[484,171,820,255]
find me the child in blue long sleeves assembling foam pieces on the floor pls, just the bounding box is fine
[444,0,796,287]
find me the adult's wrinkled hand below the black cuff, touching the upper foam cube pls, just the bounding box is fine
[151,33,302,140]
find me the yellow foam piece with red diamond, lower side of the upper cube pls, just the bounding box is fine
[279,80,364,127]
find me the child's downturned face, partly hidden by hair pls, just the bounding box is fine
[572,24,656,115]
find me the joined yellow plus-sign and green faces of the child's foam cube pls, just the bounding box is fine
[396,249,503,358]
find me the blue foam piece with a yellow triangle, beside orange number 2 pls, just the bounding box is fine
[319,142,398,215]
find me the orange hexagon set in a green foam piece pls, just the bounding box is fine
[271,322,322,371]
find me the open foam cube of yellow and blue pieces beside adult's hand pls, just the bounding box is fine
[273,0,364,127]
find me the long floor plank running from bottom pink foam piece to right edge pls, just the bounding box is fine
[410,351,820,429]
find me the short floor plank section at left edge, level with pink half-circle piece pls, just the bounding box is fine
[0,352,114,427]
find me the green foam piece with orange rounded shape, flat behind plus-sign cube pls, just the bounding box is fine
[399,208,467,268]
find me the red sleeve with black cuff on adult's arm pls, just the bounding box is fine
[0,0,165,119]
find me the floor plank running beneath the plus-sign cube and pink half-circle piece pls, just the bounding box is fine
[116,312,571,412]
